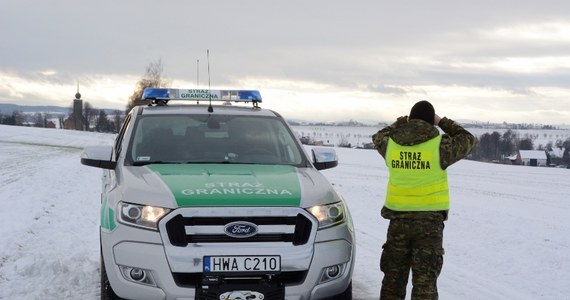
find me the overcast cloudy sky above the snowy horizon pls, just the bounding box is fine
[0,0,570,124]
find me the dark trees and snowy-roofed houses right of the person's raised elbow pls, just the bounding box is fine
[471,129,570,164]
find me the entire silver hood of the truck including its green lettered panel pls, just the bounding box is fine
[123,164,340,208]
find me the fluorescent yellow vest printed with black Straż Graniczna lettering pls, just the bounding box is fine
[384,135,449,211]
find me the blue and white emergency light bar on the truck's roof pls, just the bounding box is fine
[142,88,261,102]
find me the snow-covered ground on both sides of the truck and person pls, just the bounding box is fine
[0,126,570,300]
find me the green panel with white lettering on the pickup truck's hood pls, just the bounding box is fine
[147,164,301,206]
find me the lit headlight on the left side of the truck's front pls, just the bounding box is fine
[119,202,170,230]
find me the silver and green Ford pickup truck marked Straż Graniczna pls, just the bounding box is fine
[81,88,355,300]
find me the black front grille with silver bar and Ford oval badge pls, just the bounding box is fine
[166,214,313,247]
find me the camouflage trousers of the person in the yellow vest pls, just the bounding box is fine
[380,219,444,300]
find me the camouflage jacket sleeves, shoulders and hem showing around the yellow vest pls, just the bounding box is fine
[372,116,475,219]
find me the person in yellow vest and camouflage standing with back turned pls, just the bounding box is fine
[373,101,475,299]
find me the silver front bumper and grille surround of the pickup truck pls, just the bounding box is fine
[101,208,354,300]
